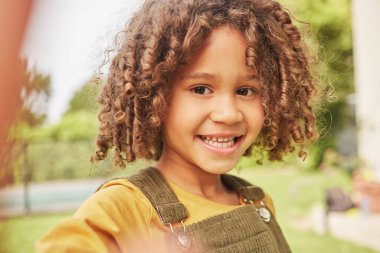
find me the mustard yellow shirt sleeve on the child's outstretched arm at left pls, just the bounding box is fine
[36,180,153,252]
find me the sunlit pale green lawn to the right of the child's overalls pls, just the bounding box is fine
[238,169,376,253]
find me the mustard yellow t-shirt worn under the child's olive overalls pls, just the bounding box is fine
[36,179,274,253]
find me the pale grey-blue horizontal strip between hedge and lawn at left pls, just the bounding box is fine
[0,179,106,218]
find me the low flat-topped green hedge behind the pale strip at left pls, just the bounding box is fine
[14,140,148,183]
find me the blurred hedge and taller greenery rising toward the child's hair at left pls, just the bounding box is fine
[0,80,104,186]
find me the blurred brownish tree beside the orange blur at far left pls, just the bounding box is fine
[0,59,51,193]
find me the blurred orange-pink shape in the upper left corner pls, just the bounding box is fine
[0,0,34,156]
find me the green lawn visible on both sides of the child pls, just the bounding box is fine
[0,169,375,253]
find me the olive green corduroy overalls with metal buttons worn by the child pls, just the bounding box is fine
[128,168,291,253]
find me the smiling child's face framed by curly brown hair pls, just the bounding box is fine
[162,26,264,174]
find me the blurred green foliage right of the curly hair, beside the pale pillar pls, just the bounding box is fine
[284,0,355,168]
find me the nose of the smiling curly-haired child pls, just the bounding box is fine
[210,96,243,125]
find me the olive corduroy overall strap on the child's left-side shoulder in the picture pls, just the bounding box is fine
[128,167,189,225]
